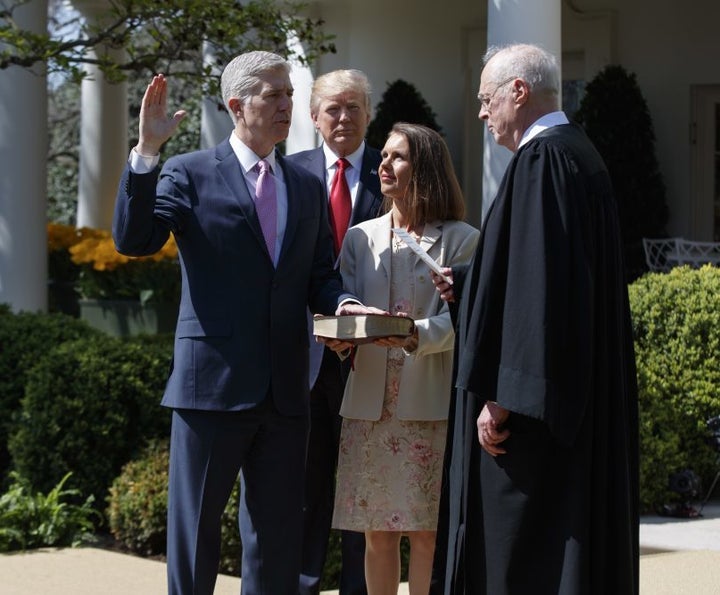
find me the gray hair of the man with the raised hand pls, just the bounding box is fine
[220,51,290,117]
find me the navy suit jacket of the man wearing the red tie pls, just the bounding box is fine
[287,144,383,387]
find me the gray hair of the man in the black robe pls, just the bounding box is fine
[483,43,560,97]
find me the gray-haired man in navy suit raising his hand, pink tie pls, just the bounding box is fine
[113,52,376,595]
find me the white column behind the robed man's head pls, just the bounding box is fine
[478,0,562,216]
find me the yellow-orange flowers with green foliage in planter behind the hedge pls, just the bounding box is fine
[48,224,180,304]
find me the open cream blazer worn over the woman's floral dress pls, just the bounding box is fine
[340,213,480,421]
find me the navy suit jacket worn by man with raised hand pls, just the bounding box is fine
[113,140,350,415]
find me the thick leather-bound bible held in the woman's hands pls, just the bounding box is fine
[313,314,415,344]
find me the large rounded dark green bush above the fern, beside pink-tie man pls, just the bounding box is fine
[9,335,171,503]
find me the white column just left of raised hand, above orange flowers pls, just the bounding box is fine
[73,0,128,229]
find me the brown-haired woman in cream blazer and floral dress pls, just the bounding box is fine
[331,124,479,595]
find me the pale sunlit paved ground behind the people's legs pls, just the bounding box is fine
[0,504,720,595]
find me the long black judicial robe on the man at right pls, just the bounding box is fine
[431,124,639,595]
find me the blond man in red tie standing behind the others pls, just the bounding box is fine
[288,70,383,595]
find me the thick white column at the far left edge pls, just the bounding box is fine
[0,0,47,312]
